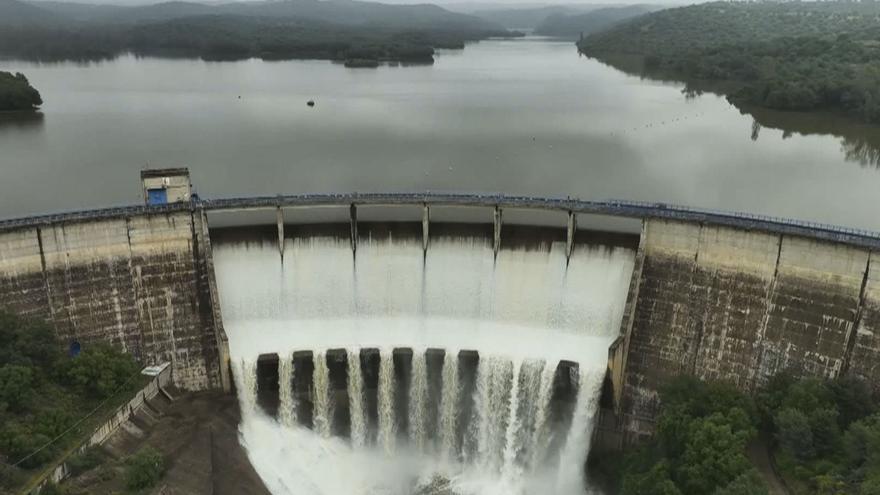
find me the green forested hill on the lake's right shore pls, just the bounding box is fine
[578,1,880,123]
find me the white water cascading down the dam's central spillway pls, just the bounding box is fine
[214,232,633,495]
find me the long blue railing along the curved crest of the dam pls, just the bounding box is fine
[0,192,880,248]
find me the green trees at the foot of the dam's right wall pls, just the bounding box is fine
[593,374,880,495]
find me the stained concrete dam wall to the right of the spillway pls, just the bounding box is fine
[620,220,880,441]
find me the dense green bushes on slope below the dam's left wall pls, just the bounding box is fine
[0,311,146,493]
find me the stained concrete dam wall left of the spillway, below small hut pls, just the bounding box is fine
[0,211,220,390]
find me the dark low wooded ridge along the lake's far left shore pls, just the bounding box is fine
[0,16,516,63]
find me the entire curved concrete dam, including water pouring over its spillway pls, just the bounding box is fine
[0,189,880,494]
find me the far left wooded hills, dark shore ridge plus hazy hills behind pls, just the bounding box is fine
[0,0,516,66]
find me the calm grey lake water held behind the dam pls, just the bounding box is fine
[0,38,880,230]
